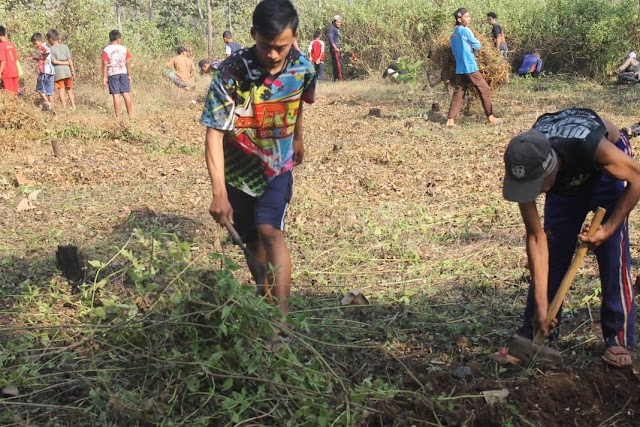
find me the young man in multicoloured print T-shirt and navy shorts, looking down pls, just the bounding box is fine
[200,0,316,345]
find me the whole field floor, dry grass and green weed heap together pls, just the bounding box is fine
[0,72,640,426]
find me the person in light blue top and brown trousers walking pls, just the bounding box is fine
[446,7,499,127]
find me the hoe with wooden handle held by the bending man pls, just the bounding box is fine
[508,208,607,362]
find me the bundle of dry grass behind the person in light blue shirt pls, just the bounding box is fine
[429,29,511,91]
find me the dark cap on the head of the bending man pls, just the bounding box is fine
[502,131,558,203]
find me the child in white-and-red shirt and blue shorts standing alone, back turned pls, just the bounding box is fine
[102,30,132,118]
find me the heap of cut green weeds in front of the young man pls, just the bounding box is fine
[0,231,404,426]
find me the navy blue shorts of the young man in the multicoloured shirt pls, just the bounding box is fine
[227,171,293,243]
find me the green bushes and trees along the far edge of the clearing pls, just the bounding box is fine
[0,0,640,80]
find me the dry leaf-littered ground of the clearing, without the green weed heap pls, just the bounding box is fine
[0,78,640,427]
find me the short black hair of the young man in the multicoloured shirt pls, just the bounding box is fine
[253,0,299,40]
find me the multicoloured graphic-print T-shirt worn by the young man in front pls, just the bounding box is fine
[200,48,315,197]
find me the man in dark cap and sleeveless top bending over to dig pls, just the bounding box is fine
[503,108,640,367]
